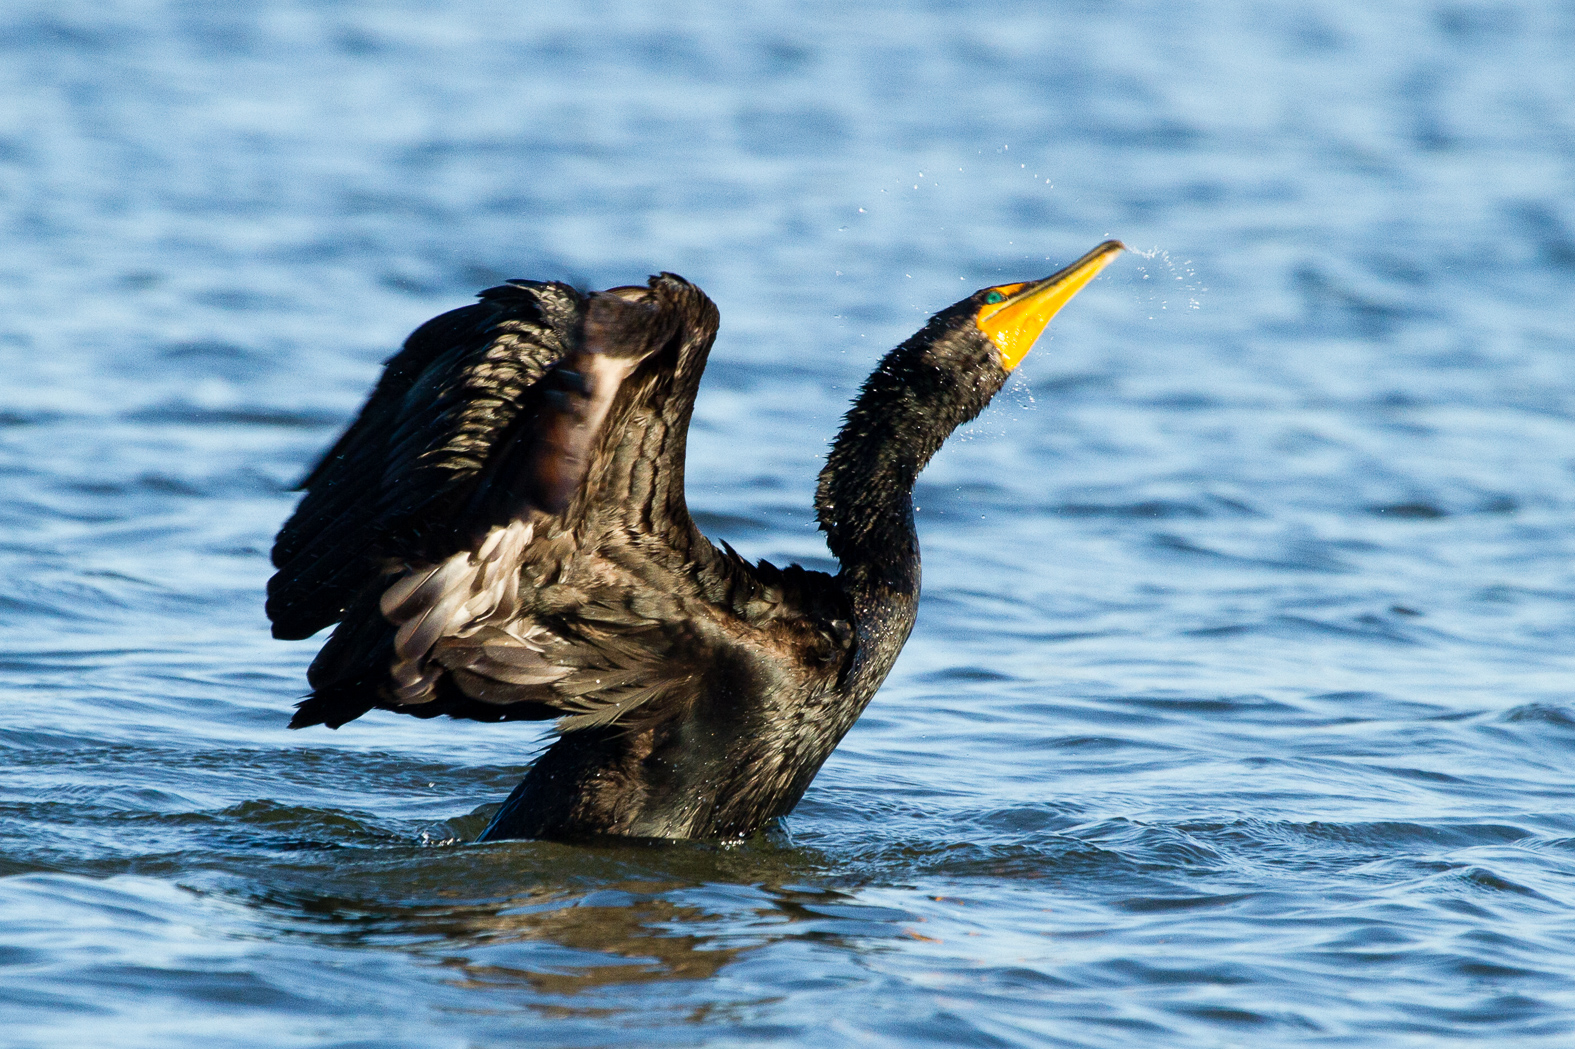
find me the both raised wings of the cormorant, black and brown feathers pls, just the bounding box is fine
[269,274,849,729]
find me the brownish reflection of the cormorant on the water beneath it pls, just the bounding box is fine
[238,835,882,1014]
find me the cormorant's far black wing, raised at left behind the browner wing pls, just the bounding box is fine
[268,280,584,639]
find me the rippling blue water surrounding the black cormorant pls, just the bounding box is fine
[0,0,1575,1047]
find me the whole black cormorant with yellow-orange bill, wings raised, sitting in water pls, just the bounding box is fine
[266,241,1123,841]
